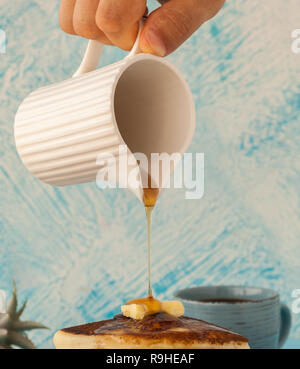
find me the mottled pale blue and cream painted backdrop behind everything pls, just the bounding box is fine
[0,0,300,347]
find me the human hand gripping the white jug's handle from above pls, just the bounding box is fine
[59,0,225,56]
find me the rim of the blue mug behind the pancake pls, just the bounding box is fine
[174,285,280,306]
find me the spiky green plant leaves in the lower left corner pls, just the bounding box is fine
[0,282,48,349]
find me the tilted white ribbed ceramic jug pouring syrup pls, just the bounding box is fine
[15,23,195,198]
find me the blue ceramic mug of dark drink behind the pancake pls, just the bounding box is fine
[175,286,291,349]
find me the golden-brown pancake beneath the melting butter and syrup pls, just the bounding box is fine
[54,313,249,349]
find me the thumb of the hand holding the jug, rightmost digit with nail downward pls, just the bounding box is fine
[140,0,225,56]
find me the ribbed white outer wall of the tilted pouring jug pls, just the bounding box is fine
[15,60,126,186]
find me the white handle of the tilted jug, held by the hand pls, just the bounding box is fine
[73,19,144,77]
